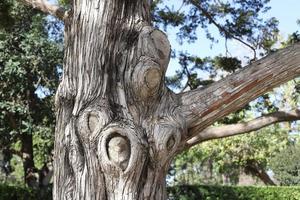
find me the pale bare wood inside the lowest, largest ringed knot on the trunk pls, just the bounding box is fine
[107,133,130,170]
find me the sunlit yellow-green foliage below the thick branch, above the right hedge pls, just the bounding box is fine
[168,79,299,185]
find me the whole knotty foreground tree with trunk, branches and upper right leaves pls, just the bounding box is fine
[1,0,300,199]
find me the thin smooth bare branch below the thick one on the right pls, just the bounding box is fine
[187,109,300,147]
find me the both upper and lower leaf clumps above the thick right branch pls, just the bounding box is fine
[161,0,279,91]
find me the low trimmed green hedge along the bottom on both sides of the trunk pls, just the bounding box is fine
[0,184,300,200]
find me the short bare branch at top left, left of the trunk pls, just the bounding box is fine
[22,0,66,20]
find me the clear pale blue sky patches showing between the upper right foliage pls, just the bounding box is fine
[167,0,300,76]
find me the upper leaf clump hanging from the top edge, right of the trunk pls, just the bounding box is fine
[153,0,278,47]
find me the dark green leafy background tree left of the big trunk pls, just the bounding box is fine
[0,0,62,187]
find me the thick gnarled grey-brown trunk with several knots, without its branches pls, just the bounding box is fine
[53,0,186,200]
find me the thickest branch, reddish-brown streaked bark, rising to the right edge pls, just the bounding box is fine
[179,43,300,138]
